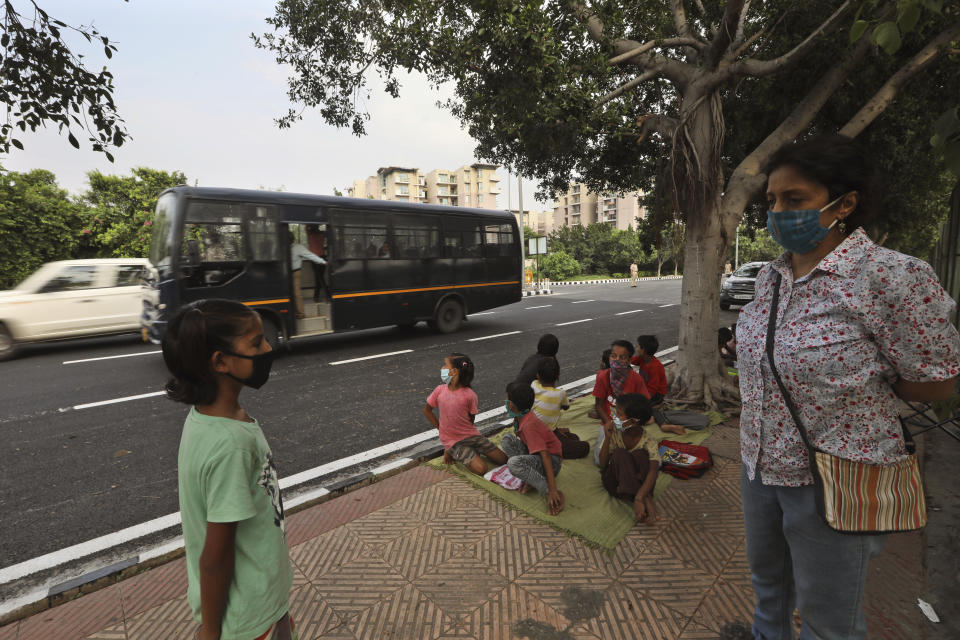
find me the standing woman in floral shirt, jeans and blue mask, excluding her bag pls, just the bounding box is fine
[737,136,960,639]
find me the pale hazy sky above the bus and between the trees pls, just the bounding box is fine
[0,0,549,209]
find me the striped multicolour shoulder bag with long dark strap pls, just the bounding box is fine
[766,273,927,534]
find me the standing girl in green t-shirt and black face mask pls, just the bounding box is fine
[163,300,295,640]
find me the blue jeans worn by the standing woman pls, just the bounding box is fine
[740,467,886,640]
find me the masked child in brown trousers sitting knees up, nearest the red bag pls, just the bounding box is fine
[595,393,660,522]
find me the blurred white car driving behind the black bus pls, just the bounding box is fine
[0,258,150,360]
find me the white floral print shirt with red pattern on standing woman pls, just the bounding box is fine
[737,229,960,487]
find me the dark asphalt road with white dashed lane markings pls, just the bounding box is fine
[0,280,736,566]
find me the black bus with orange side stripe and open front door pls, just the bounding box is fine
[140,186,523,346]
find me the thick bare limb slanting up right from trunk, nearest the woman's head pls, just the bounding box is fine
[722,29,872,218]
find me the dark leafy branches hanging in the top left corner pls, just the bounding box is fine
[0,0,129,162]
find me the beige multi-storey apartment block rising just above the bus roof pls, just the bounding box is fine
[347,163,500,209]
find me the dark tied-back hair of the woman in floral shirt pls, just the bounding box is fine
[766,134,880,234]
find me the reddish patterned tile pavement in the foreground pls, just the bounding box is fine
[0,424,923,640]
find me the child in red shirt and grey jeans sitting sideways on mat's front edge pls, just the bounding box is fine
[500,382,563,516]
